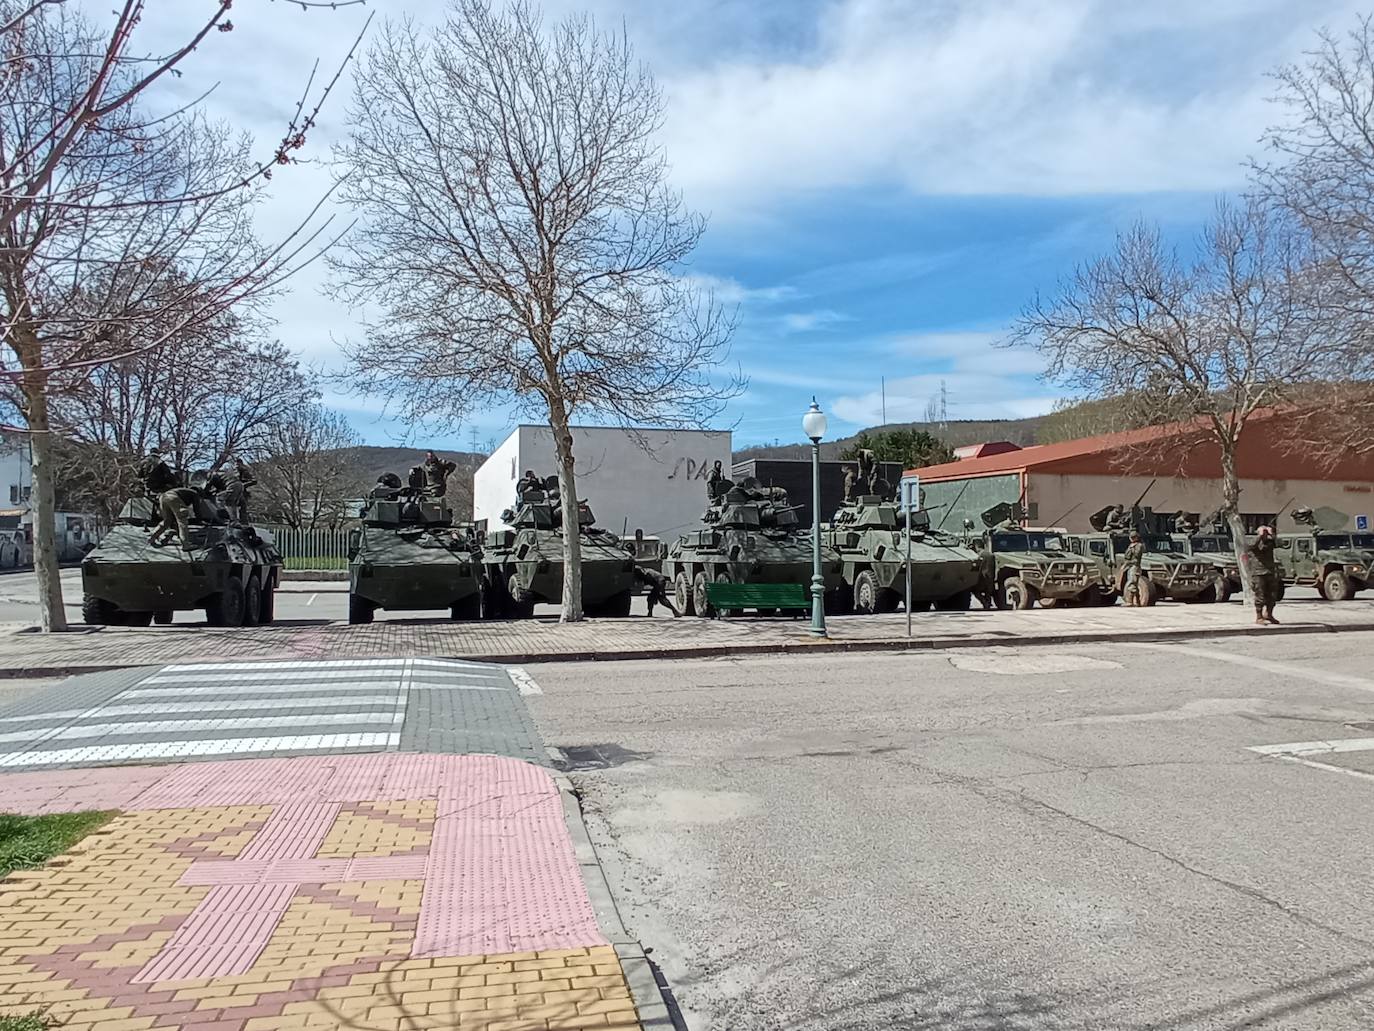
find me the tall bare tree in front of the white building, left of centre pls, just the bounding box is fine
[331,0,738,620]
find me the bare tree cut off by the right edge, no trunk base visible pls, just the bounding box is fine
[1252,16,1374,462]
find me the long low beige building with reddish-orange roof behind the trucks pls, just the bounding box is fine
[910,412,1374,532]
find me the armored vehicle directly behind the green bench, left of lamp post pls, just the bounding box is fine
[664,477,849,616]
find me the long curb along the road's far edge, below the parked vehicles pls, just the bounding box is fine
[0,621,1374,680]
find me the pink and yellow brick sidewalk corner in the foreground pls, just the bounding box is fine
[0,755,640,1031]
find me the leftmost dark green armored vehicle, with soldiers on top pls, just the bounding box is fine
[81,495,282,627]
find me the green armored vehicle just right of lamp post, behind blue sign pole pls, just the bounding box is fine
[822,495,980,613]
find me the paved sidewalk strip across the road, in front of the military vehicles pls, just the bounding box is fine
[0,599,1374,674]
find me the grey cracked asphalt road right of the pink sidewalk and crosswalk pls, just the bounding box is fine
[528,634,1374,1031]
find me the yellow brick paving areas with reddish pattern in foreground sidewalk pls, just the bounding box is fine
[0,801,639,1031]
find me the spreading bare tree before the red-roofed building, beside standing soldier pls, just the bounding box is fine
[1009,202,1347,596]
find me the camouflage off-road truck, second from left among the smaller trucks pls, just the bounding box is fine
[1063,509,1216,605]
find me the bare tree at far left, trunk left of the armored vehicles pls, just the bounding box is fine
[0,0,362,630]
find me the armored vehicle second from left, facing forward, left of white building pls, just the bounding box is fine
[348,470,482,623]
